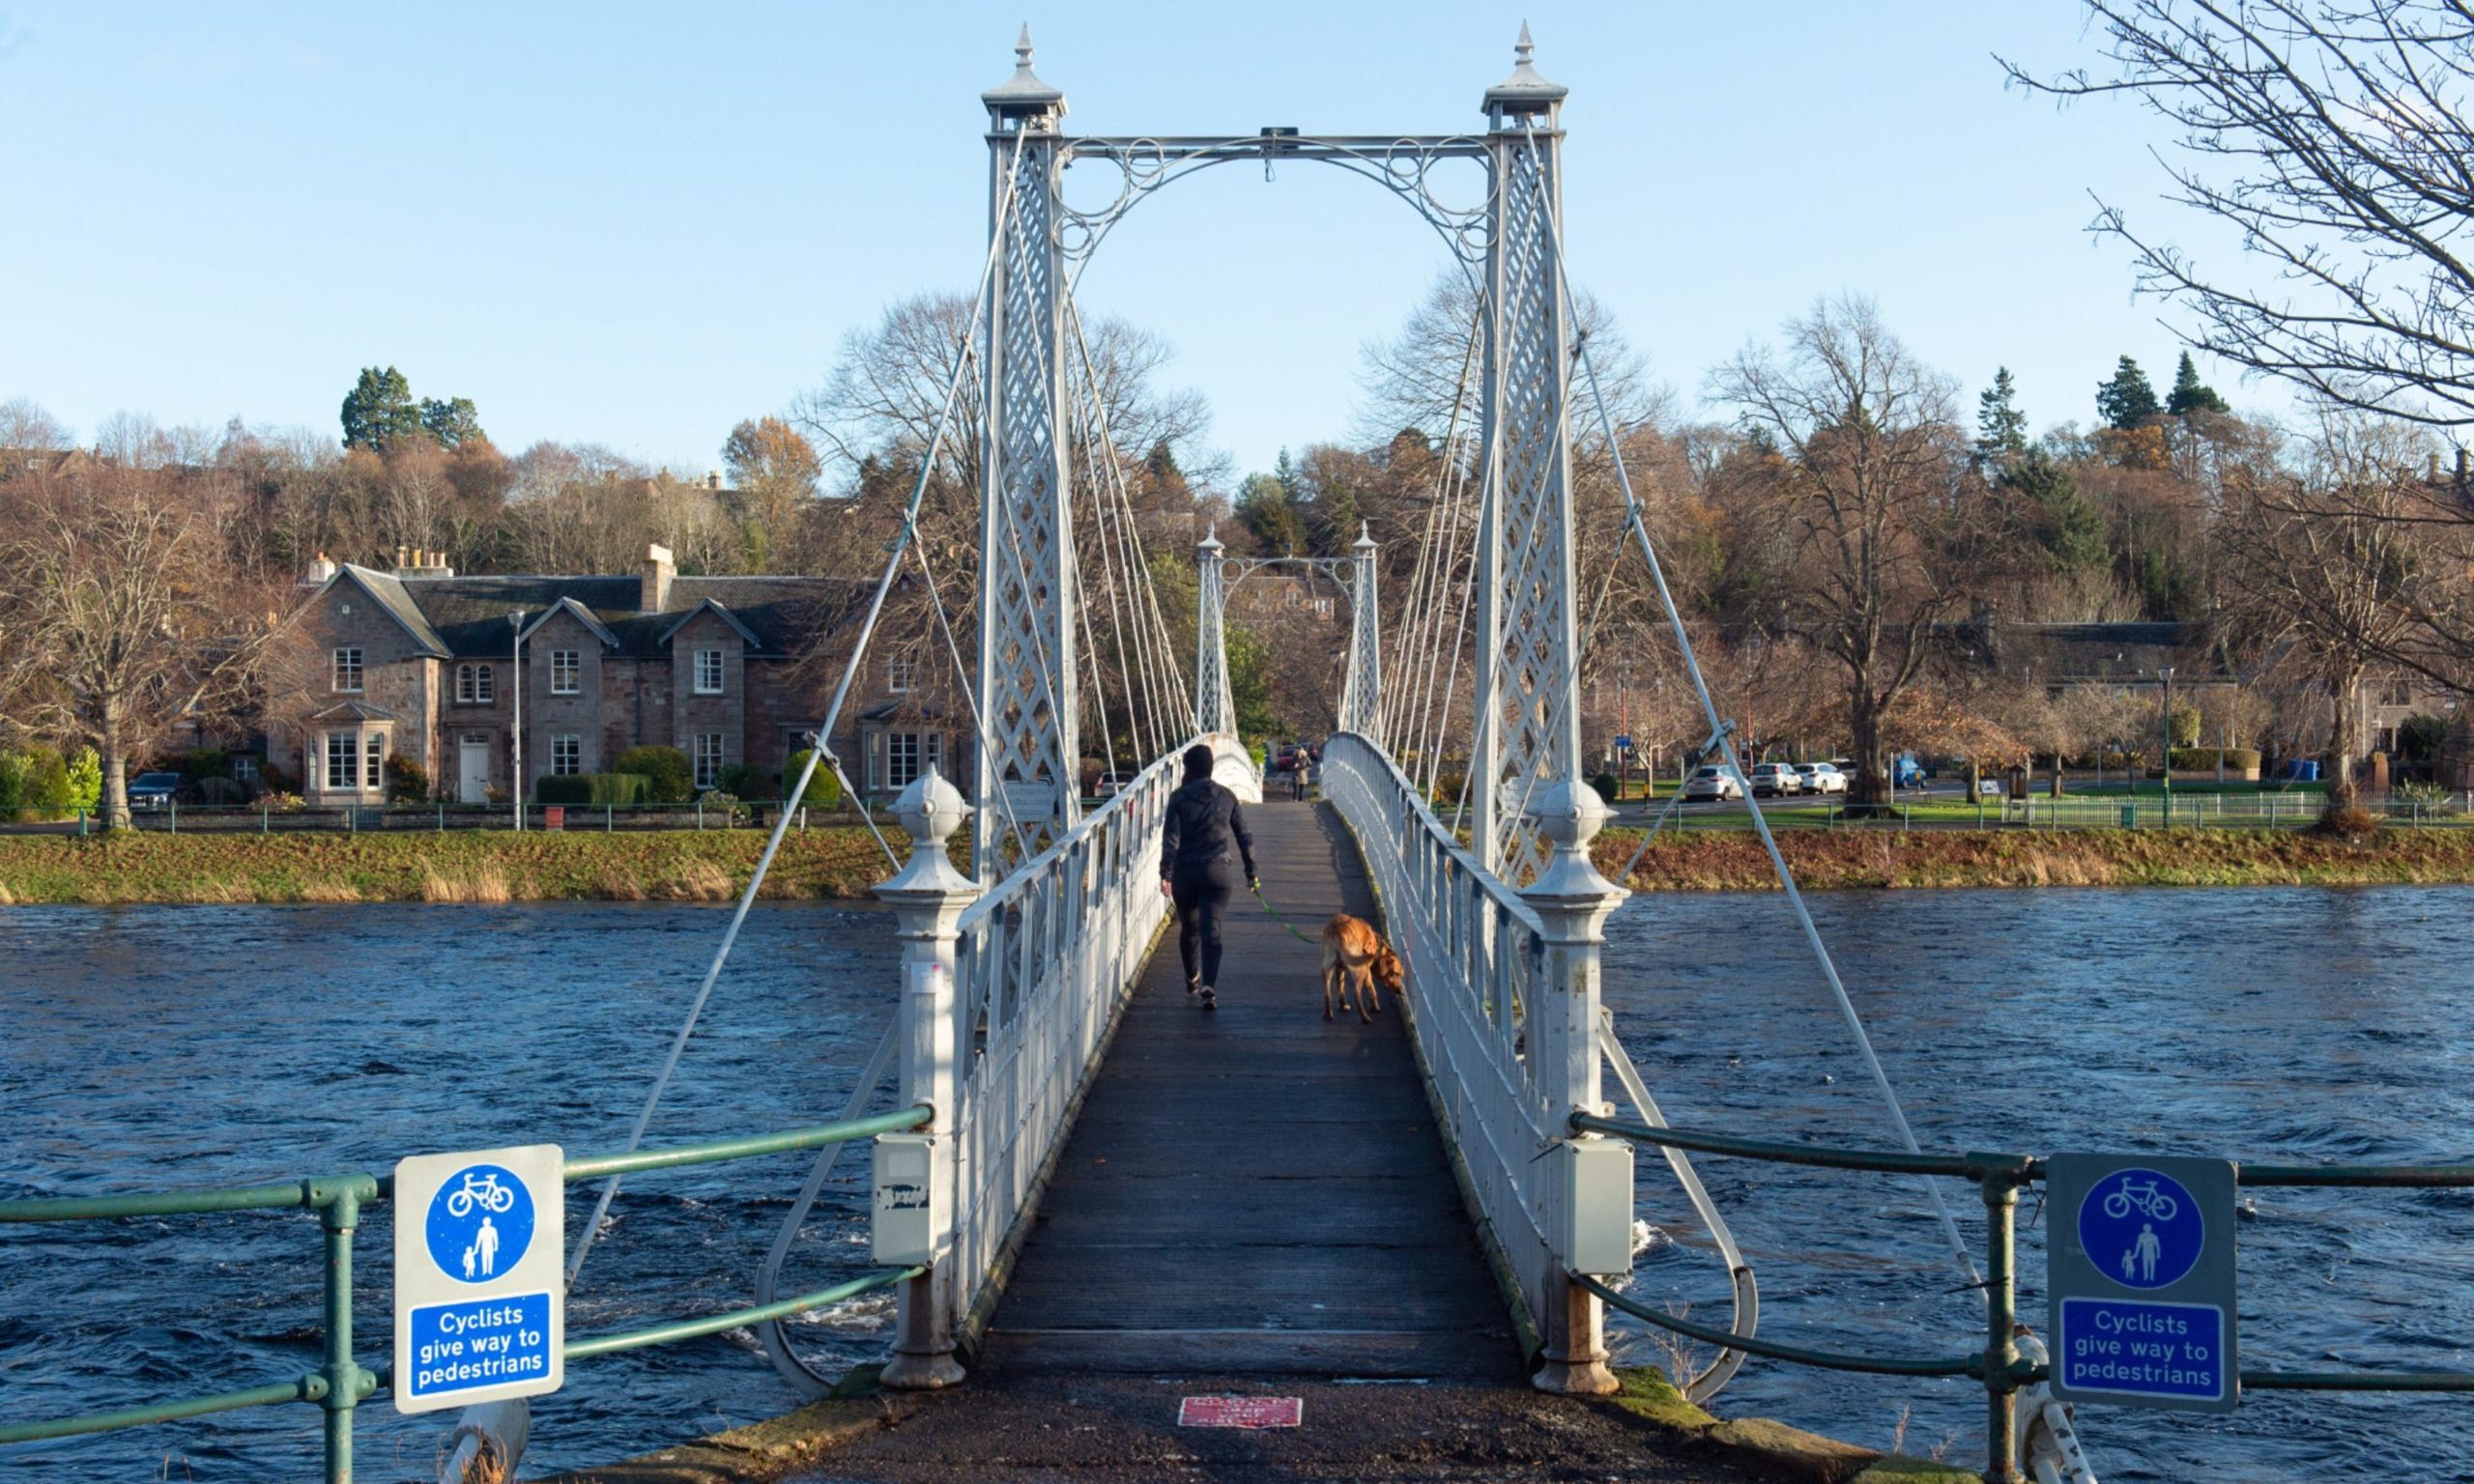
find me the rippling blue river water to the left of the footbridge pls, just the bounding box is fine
[0,905,896,1479]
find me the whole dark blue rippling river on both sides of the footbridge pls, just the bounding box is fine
[0,888,2474,1481]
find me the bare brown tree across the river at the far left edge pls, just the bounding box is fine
[0,465,274,829]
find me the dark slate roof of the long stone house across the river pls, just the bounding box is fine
[363,569,871,661]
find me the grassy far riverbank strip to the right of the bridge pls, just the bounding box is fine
[1594,829,2474,891]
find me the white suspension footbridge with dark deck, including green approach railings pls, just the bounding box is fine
[0,27,2474,1481]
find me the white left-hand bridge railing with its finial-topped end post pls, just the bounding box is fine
[878,737,1262,1387]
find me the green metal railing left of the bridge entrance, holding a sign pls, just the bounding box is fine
[0,1108,931,1484]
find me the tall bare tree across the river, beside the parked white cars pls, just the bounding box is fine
[1712,300,1997,807]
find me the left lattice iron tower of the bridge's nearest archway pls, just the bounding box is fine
[972,54,1081,878]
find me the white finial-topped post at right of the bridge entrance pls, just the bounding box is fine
[1521,779,1630,1395]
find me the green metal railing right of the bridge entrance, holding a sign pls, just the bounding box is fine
[1571,1113,2474,1484]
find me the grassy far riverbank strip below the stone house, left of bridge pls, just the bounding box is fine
[0,826,906,905]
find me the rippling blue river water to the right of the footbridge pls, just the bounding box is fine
[1605,888,2474,1481]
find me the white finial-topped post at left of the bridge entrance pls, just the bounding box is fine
[876,764,980,1390]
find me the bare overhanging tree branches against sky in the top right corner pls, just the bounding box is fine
[2004,0,2474,425]
